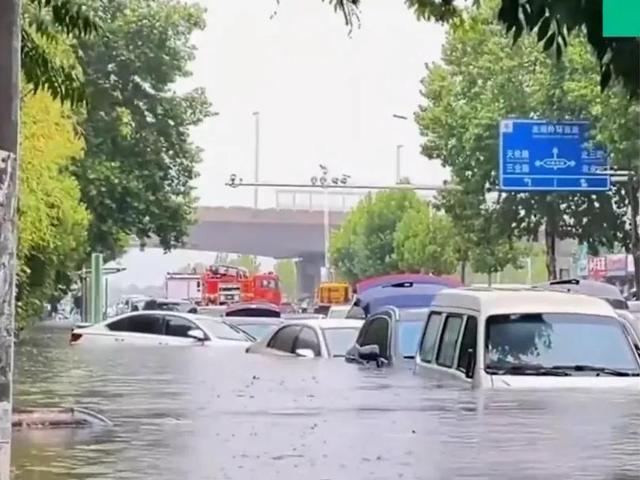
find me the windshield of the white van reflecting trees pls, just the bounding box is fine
[485,313,638,374]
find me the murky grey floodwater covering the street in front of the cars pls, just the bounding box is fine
[8,322,640,480]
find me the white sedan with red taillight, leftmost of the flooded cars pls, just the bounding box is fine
[70,311,255,348]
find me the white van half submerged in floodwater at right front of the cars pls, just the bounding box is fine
[416,288,640,389]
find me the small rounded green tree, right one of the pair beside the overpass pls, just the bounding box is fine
[394,202,458,275]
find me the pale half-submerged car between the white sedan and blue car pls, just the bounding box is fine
[247,319,362,358]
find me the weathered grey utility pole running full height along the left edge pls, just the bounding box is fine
[0,0,21,480]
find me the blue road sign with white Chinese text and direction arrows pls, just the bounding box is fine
[499,119,611,192]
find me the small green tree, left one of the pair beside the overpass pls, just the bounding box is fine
[330,190,423,282]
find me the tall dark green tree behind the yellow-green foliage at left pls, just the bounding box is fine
[73,0,211,257]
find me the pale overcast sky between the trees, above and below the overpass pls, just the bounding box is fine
[114,0,445,284]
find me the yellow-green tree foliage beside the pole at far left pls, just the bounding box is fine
[17,92,89,325]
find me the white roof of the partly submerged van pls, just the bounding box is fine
[431,287,615,317]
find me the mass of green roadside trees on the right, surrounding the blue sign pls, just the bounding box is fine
[333,0,640,279]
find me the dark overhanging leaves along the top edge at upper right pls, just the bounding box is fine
[334,0,640,98]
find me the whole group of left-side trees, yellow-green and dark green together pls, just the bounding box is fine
[17,0,211,326]
